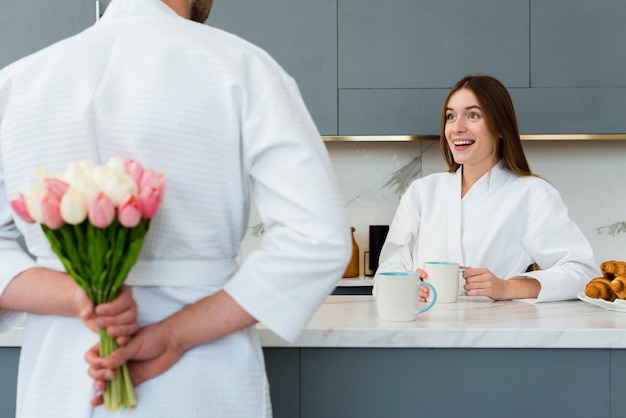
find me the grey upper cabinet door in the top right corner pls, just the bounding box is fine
[530,0,626,88]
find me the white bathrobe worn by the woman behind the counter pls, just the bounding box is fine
[377,162,601,302]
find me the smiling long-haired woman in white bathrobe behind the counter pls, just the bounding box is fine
[377,75,601,302]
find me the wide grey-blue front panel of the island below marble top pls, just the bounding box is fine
[298,348,608,418]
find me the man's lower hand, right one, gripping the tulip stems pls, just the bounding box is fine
[85,322,184,406]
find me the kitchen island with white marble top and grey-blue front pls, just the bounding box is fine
[0,295,626,418]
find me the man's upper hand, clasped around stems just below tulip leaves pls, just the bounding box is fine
[74,286,140,345]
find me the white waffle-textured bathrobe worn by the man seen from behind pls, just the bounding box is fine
[0,0,350,418]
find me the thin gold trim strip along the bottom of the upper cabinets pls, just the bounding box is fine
[322,134,626,142]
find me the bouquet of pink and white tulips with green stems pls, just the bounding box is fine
[11,158,165,410]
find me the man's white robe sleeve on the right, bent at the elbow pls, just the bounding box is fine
[224,70,351,341]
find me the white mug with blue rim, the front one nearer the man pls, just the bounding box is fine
[376,271,437,321]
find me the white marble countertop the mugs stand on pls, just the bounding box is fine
[0,296,626,349]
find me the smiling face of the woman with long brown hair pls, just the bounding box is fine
[445,88,497,172]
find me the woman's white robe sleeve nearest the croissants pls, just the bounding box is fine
[523,181,601,302]
